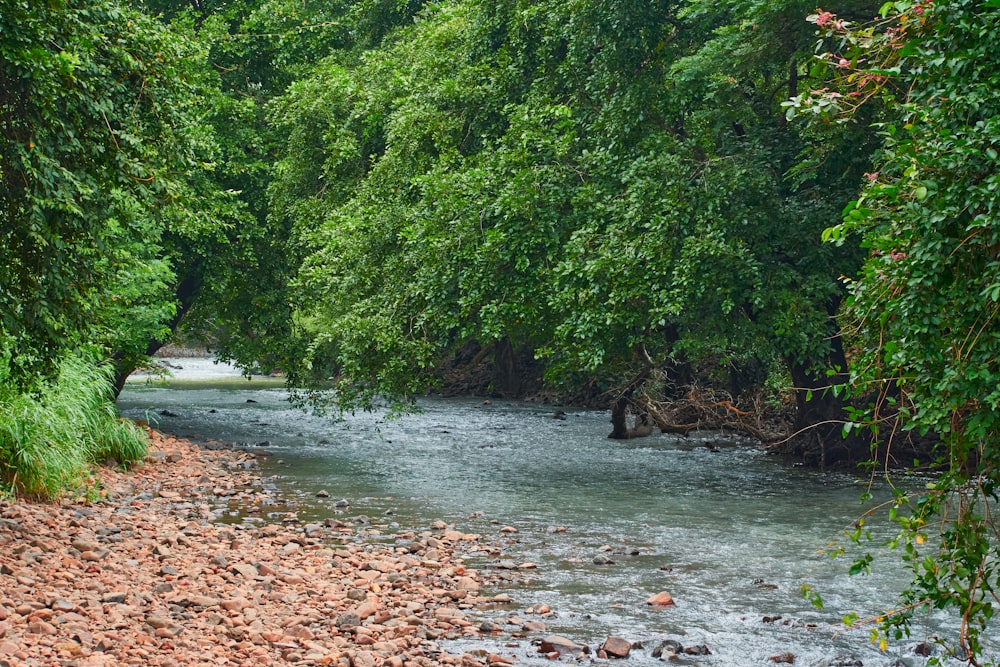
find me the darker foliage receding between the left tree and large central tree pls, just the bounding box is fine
[132,0,419,378]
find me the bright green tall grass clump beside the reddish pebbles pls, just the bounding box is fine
[0,356,149,498]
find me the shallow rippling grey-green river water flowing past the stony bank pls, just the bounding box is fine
[119,359,949,666]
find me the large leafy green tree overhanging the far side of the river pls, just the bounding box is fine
[274,1,873,452]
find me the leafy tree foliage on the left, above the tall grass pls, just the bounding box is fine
[0,0,234,388]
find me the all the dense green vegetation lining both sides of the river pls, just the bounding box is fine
[0,0,1000,656]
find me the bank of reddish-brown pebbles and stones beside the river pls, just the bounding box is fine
[0,432,509,667]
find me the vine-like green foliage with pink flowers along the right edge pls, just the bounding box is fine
[791,0,1000,664]
